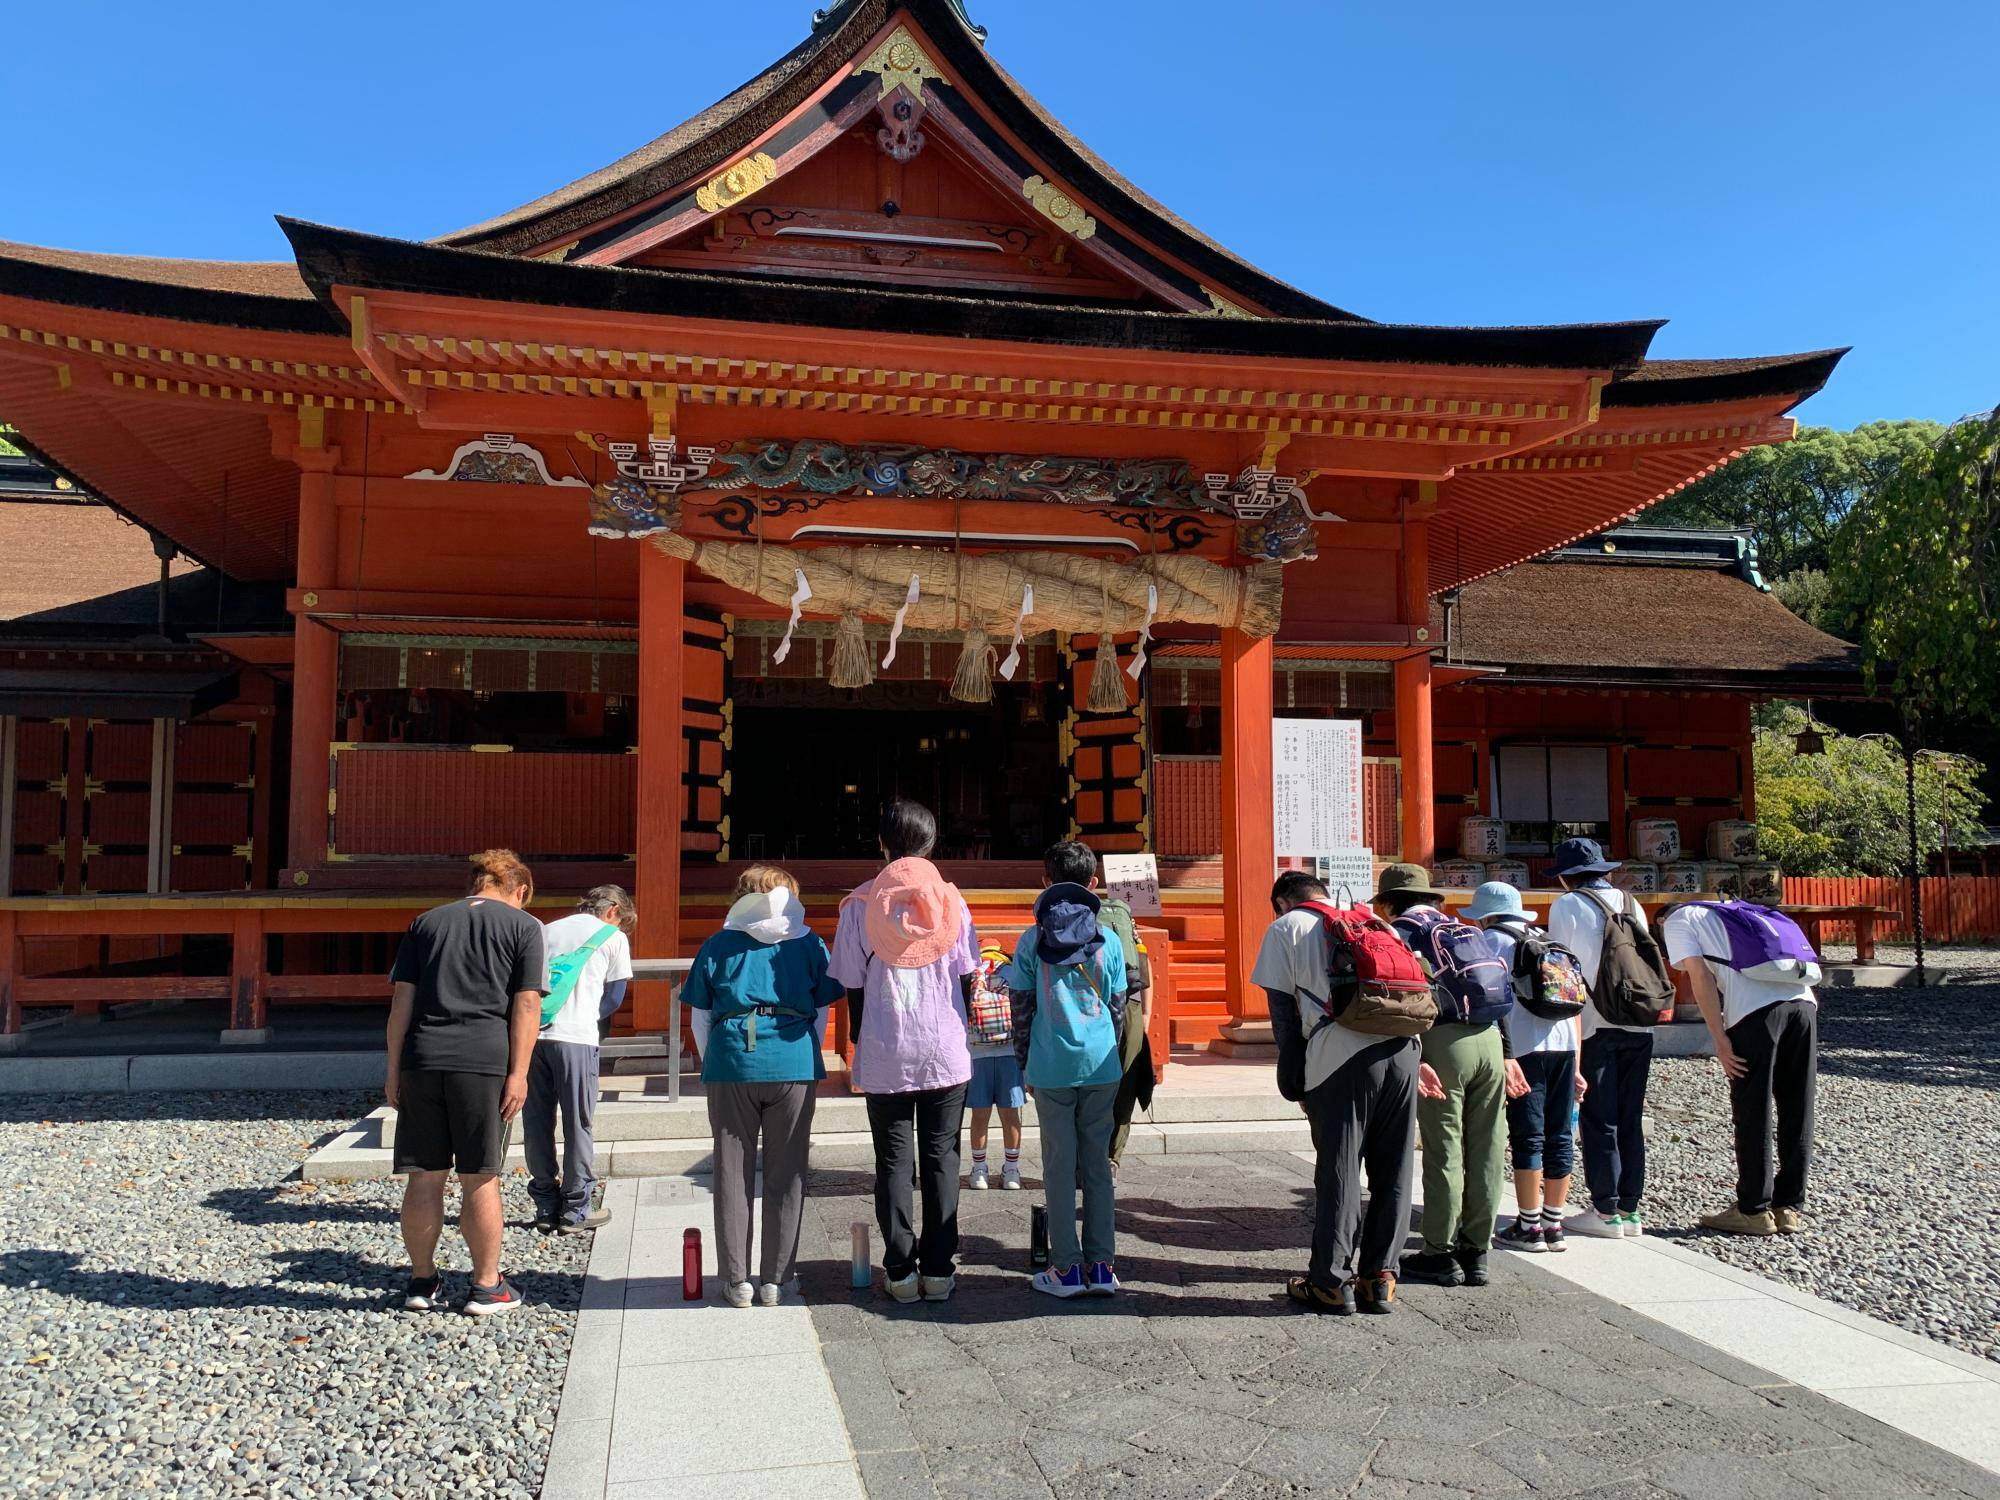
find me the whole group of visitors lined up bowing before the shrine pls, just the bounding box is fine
[386,800,1818,1316]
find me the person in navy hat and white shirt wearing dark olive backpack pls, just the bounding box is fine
[1548,838,1652,1240]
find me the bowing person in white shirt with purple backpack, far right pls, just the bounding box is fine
[1660,902,1820,1236]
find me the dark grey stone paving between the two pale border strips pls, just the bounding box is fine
[804,1152,2000,1500]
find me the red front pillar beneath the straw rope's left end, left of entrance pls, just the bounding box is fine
[632,544,686,1032]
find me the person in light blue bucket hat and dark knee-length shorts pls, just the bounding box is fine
[1464,880,1584,1252]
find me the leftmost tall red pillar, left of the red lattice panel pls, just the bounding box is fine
[286,470,340,886]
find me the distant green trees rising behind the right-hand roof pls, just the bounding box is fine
[1642,422,1944,578]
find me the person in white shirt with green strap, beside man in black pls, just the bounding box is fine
[520,886,638,1234]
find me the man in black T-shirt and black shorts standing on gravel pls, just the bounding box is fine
[384,850,546,1318]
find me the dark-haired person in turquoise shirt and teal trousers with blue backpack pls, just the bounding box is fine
[1006,842,1126,1298]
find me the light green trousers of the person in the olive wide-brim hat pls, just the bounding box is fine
[1416,1022,1506,1254]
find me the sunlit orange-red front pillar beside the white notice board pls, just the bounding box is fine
[1210,630,1278,1054]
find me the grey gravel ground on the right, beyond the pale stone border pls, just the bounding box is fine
[1646,964,2000,1360]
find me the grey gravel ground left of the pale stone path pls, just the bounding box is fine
[0,1094,588,1500]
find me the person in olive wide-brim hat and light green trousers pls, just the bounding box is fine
[1376,864,1514,1286]
